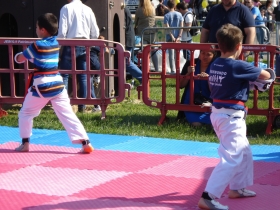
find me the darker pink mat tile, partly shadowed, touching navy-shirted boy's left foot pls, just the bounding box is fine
[72,174,206,207]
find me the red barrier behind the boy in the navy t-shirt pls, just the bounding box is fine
[138,43,280,134]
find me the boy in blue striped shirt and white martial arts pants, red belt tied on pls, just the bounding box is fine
[15,13,93,153]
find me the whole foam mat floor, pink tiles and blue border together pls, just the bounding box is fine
[0,126,280,210]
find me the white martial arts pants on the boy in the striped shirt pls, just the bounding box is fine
[18,88,89,143]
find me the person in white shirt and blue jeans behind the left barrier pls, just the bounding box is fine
[57,0,99,112]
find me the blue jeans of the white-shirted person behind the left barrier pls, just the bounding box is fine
[60,46,96,109]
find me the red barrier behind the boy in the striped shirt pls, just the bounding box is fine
[0,38,130,118]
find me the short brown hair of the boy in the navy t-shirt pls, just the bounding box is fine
[216,23,243,53]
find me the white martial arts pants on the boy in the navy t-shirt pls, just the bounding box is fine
[205,107,253,198]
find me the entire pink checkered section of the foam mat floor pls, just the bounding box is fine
[0,143,280,210]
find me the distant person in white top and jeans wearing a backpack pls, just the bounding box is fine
[176,2,193,61]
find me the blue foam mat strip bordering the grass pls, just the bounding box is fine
[0,126,280,162]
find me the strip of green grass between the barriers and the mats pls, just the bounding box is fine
[0,76,280,145]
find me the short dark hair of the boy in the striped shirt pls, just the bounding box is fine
[37,13,58,36]
